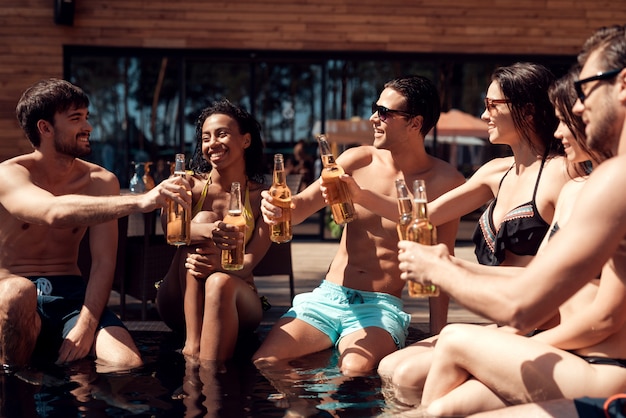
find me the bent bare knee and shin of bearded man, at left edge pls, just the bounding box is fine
[0,276,41,366]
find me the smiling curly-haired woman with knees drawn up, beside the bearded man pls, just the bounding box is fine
[157,100,270,362]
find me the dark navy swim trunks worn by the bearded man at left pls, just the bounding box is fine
[28,276,125,361]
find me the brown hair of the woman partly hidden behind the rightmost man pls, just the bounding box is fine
[548,67,610,176]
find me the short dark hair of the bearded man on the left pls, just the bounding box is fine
[15,78,89,148]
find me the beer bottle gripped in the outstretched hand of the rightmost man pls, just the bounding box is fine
[407,180,439,297]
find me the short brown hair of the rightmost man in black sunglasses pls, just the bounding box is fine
[578,25,626,71]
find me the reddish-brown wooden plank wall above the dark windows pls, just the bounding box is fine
[0,0,626,160]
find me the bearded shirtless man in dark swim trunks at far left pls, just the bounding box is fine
[0,78,190,369]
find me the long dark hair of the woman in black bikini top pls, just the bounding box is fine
[491,62,563,155]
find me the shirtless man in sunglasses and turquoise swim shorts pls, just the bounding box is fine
[253,76,465,374]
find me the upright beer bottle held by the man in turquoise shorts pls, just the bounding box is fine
[269,154,292,244]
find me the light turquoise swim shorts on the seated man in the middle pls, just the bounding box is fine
[283,280,411,349]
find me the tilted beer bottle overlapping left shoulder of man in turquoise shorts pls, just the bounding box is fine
[317,134,356,225]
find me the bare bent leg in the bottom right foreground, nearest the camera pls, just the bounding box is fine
[422,324,626,415]
